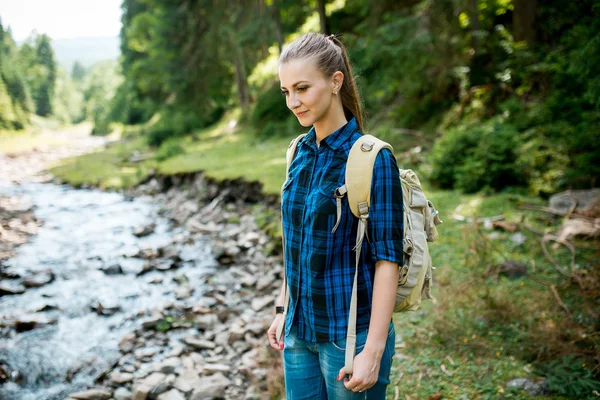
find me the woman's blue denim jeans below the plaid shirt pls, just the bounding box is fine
[283,322,396,400]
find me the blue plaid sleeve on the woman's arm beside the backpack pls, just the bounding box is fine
[367,149,404,265]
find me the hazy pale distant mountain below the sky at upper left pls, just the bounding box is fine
[52,36,121,72]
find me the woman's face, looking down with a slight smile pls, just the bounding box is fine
[279,60,341,127]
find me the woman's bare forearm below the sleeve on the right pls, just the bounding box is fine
[365,260,398,359]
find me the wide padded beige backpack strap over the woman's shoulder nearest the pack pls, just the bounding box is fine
[346,135,394,218]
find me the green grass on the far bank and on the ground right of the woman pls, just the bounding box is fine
[52,115,600,399]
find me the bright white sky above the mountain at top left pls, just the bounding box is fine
[0,0,122,41]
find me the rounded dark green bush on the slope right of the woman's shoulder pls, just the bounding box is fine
[431,118,526,193]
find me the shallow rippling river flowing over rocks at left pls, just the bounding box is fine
[0,183,216,400]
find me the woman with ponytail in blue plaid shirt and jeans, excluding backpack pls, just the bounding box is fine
[268,33,403,400]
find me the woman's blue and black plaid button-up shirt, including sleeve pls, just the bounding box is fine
[281,118,403,342]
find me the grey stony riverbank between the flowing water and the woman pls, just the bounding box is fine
[61,174,283,400]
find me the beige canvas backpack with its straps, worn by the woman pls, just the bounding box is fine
[277,135,442,374]
